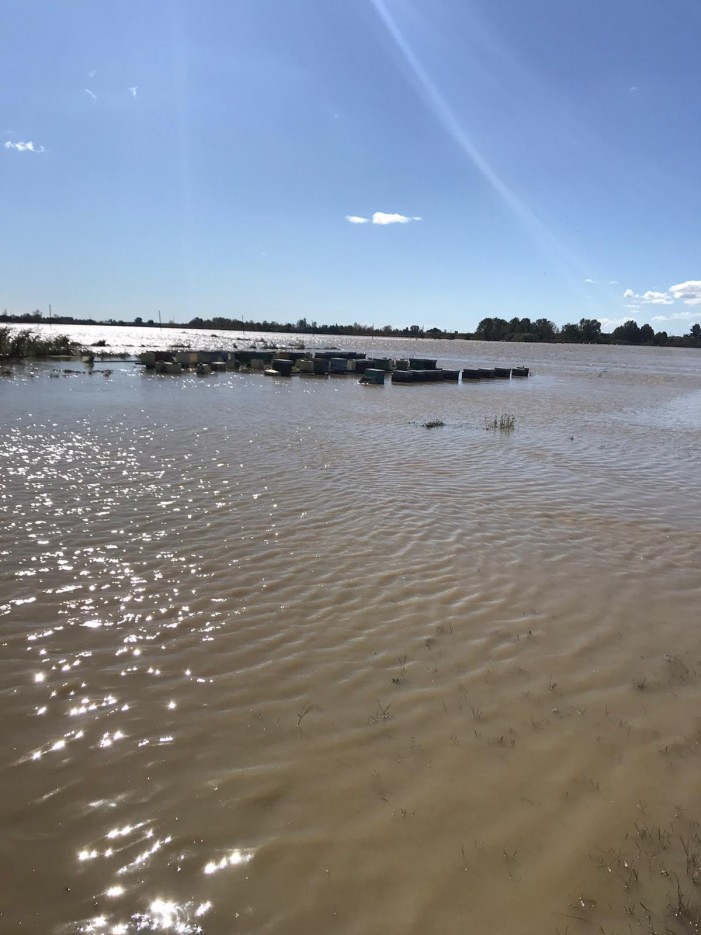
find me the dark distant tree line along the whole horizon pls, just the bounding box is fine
[0,311,701,347]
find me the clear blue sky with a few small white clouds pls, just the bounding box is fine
[0,0,701,334]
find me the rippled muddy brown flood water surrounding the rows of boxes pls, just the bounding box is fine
[0,328,701,935]
